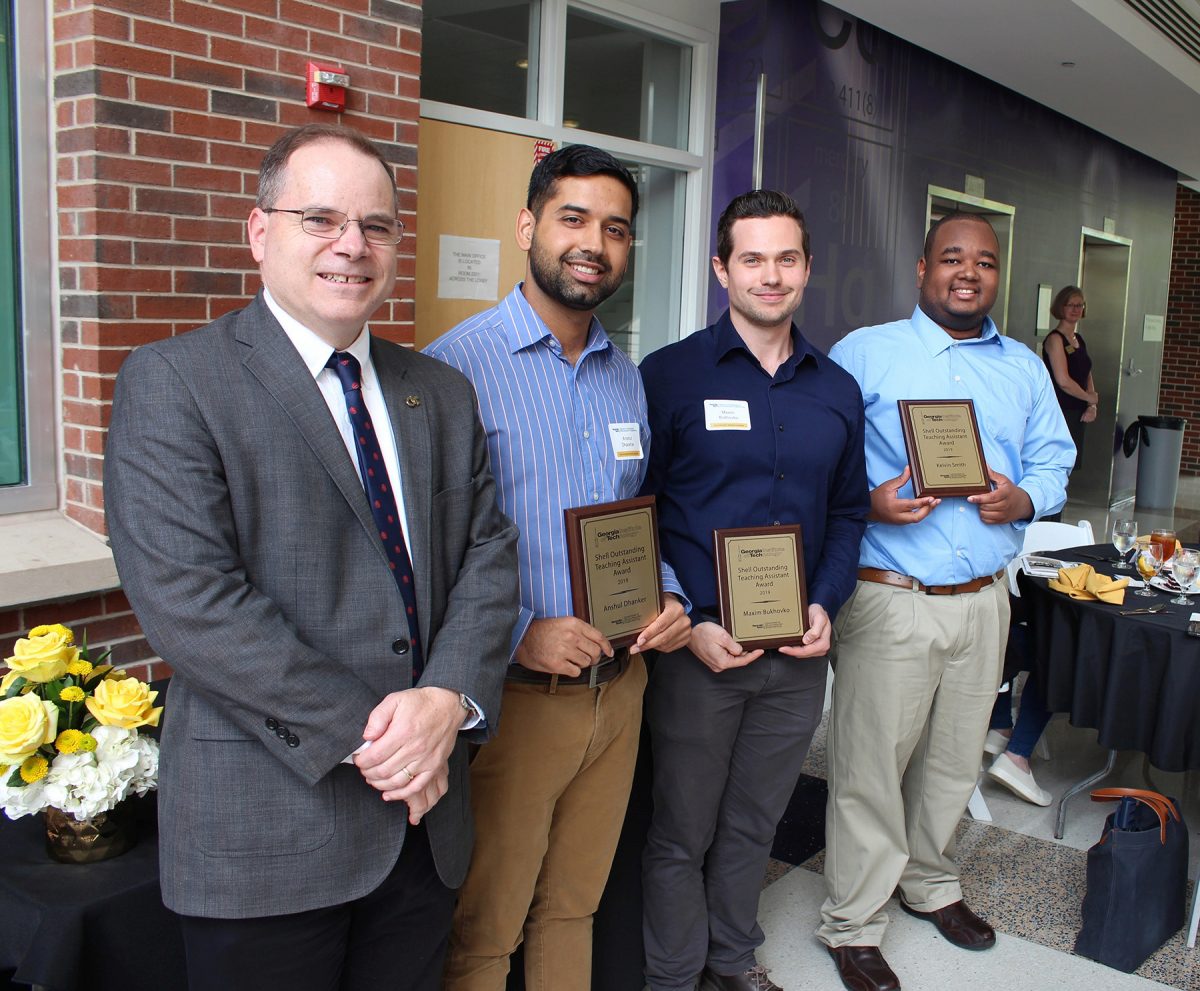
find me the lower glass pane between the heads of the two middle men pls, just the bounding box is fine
[596,161,694,362]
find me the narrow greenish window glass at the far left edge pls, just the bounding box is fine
[0,2,22,485]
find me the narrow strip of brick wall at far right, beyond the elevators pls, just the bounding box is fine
[1158,186,1200,475]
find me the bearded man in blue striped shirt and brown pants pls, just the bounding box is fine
[427,145,691,991]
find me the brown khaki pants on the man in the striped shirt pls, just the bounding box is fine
[445,655,646,991]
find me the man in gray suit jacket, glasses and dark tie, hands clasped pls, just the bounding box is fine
[106,126,517,991]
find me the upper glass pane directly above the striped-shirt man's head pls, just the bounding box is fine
[563,10,691,148]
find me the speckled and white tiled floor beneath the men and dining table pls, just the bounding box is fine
[760,479,1200,991]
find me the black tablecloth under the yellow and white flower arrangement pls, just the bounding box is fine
[0,793,187,991]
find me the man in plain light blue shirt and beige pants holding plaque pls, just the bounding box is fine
[817,214,1075,991]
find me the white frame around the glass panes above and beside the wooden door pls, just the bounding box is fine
[420,0,718,337]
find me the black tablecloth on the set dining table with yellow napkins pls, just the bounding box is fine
[1018,543,1200,771]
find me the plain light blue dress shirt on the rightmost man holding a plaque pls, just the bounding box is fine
[829,307,1075,585]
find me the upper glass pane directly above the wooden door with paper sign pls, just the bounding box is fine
[421,0,540,118]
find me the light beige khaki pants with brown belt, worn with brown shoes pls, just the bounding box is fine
[817,581,1009,947]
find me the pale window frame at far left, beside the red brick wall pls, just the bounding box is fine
[0,0,61,515]
